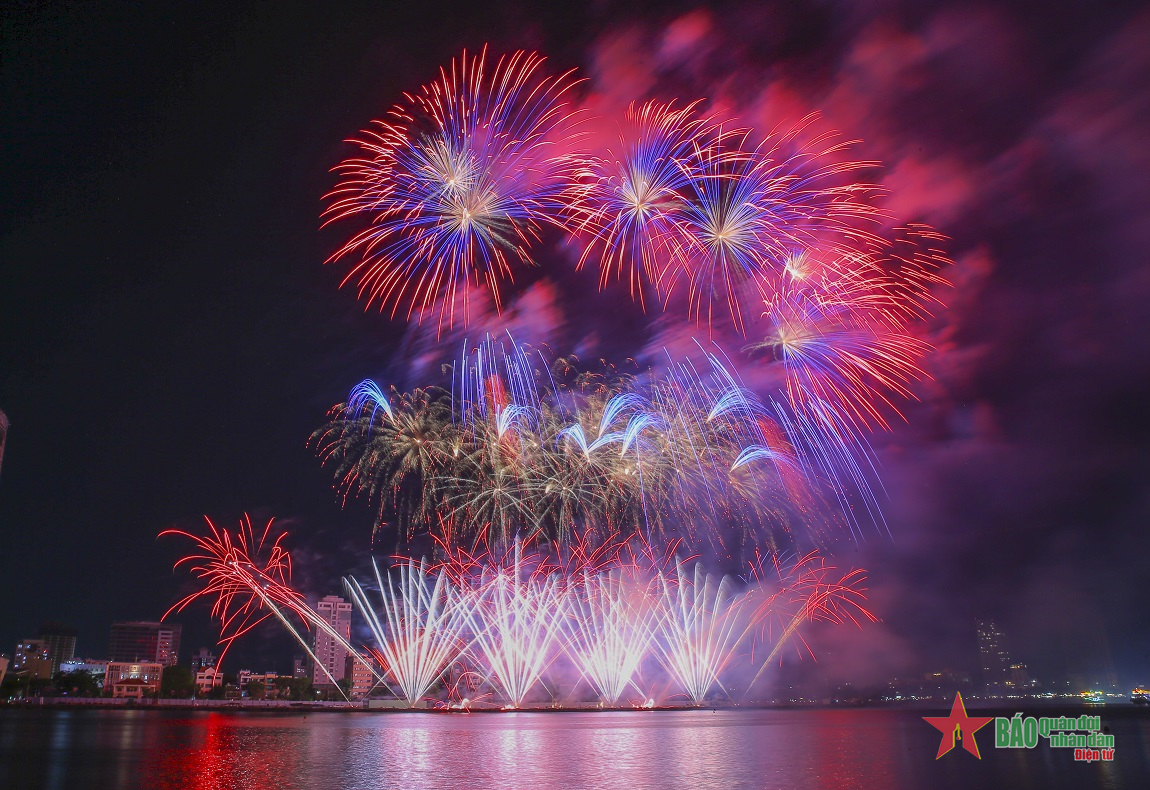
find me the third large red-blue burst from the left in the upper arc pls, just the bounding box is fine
[657,116,884,336]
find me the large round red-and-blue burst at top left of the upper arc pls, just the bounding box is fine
[327,51,577,324]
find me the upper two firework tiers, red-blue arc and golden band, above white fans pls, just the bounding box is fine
[314,51,949,554]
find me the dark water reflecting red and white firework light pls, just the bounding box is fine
[0,707,1150,790]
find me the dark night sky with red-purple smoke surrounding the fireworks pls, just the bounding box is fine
[0,1,1150,683]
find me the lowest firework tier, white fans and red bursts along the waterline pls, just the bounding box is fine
[168,521,873,707]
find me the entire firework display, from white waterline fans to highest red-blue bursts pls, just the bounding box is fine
[164,51,949,707]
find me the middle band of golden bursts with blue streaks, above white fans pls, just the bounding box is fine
[313,339,820,553]
